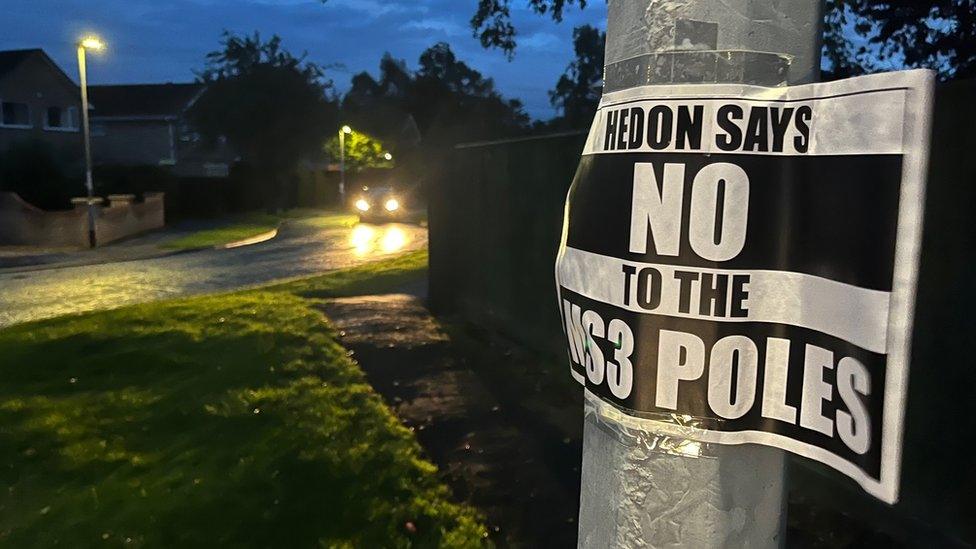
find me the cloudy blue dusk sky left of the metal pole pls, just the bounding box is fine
[0,0,606,118]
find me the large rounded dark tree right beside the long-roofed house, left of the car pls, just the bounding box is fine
[189,33,338,209]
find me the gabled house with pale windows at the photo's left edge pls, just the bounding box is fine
[0,49,83,161]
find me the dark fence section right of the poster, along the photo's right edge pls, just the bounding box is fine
[876,80,976,544]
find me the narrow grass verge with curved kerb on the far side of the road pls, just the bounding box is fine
[162,209,358,250]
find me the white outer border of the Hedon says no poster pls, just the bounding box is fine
[556,70,935,503]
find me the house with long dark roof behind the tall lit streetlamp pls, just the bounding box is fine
[88,83,235,177]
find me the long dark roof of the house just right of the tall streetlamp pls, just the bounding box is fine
[88,83,204,118]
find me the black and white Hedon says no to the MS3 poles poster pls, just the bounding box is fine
[556,71,933,503]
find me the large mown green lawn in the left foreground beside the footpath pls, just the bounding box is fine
[0,252,485,548]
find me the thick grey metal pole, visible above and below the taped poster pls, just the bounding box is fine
[579,0,823,548]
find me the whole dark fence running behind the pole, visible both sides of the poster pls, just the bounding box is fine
[429,80,976,547]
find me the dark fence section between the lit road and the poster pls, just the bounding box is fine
[428,132,585,356]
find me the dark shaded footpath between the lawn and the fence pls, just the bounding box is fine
[323,294,583,547]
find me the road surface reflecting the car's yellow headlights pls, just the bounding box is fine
[0,222,427,327]
